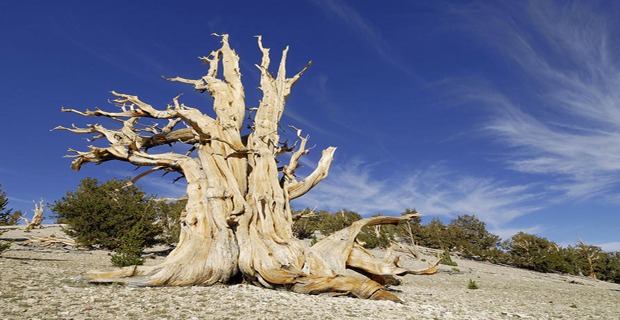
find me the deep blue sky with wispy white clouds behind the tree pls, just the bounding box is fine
[0,0,620,250]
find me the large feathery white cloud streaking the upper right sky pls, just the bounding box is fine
[455,1,620,200]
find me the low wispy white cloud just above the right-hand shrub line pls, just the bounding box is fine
[295,159,540,228]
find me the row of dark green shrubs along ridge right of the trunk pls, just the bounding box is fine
[294,209,620,283]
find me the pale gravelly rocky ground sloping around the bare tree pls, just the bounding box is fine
[0,226,620,319]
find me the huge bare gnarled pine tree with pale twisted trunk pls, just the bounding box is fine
[56,35,434,301]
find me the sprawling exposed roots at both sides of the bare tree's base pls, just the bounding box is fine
[84,216,440,302]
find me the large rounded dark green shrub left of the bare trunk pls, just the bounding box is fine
[52,178,162,250]
